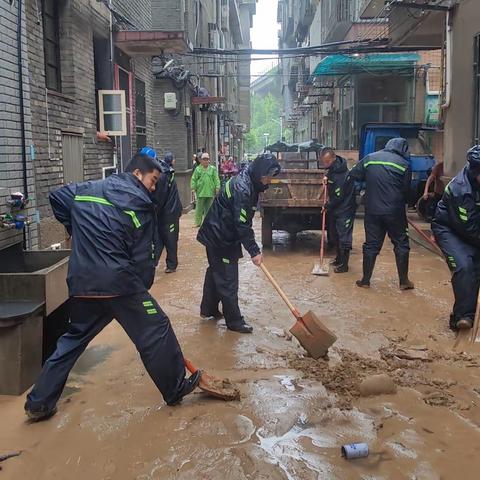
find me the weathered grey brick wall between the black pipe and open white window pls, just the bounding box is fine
[26,0,112,248]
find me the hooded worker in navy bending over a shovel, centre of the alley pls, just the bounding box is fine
[197,154,280,333]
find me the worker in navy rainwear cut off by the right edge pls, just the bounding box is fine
[432,145,480,330]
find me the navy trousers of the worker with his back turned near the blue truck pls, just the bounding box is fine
[363,212,410,257]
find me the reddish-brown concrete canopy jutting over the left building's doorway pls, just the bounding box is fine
[115,30,192,57]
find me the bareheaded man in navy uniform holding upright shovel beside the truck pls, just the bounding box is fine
[320,148,356,273]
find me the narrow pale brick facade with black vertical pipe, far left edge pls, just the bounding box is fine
[0,1,38,249]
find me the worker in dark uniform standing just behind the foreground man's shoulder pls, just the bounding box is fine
[140,147,183,273]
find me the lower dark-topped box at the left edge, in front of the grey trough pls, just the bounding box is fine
[0,302,45,395]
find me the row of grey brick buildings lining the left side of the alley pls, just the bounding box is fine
[0,0,256,248]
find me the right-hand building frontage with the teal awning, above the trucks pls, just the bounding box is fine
[279,0,442,161]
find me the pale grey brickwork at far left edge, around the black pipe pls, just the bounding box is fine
[0,1,38,249]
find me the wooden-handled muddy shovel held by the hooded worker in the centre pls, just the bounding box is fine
[260,263,337,360]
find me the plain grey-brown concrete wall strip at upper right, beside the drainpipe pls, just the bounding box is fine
[444,0,480,176]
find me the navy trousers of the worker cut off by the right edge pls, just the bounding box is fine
[432,223,480,326]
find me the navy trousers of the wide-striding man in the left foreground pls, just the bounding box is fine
[27,292,185,411]
